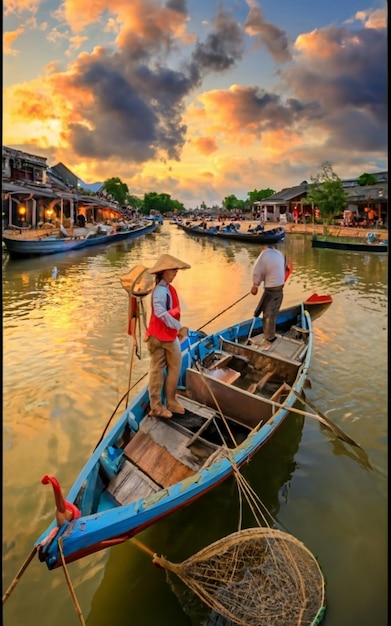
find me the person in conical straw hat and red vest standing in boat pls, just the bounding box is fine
[145,254,190,418]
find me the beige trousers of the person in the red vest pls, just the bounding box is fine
[147,337,182,411]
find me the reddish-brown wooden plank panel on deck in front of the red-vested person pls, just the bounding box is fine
[124,431,194,487]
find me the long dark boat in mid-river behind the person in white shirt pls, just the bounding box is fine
[177,222,285,245]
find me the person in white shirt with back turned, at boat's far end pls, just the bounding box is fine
[251,247,285,350]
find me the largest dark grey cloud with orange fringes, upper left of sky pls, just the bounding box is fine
[3,2,243,163]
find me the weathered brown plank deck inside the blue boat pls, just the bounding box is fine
[107,327,307,504]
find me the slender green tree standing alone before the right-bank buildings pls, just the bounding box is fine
[306,161,348,224]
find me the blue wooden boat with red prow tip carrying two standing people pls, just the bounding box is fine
[35,294,332,569]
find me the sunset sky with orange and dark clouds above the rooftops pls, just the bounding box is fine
[3,0,388,209]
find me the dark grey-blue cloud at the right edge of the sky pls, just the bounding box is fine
[288,27,387,125]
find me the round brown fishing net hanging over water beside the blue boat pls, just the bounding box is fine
[153,527,325,626]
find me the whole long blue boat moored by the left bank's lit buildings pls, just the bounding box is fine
[3,220,157,258]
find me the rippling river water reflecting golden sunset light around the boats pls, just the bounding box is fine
[3,222,388,626]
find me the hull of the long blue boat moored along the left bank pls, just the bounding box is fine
[3,221,157,258]
